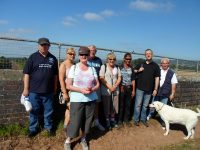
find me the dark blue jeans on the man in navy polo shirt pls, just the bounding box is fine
[29,93,53,132]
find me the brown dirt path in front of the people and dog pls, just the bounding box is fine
[0,120,200,150]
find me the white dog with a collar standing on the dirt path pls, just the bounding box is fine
[149,101,200,139]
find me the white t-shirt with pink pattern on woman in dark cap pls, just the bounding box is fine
[68,63,97,102]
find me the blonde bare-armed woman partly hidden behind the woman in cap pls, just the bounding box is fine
[59,48,76,130]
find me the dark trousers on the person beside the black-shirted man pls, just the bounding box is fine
[119,86,132,123]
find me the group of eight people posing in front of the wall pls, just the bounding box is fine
[22,38,178,150]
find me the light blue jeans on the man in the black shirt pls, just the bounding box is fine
[133,89,151,122]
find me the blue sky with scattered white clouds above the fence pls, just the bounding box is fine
[0,0,200,60]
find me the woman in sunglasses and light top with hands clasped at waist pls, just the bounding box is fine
[99,53,121,129]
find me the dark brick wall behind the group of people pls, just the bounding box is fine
[0,70,200,125]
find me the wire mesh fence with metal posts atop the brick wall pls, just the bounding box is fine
[0,37,199,73]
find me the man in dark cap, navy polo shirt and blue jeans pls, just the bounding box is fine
[22,38,58,137]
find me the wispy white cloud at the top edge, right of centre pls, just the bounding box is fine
[129,0,174,11]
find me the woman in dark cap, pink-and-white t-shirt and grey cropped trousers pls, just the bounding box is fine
[64,47,99,150]
